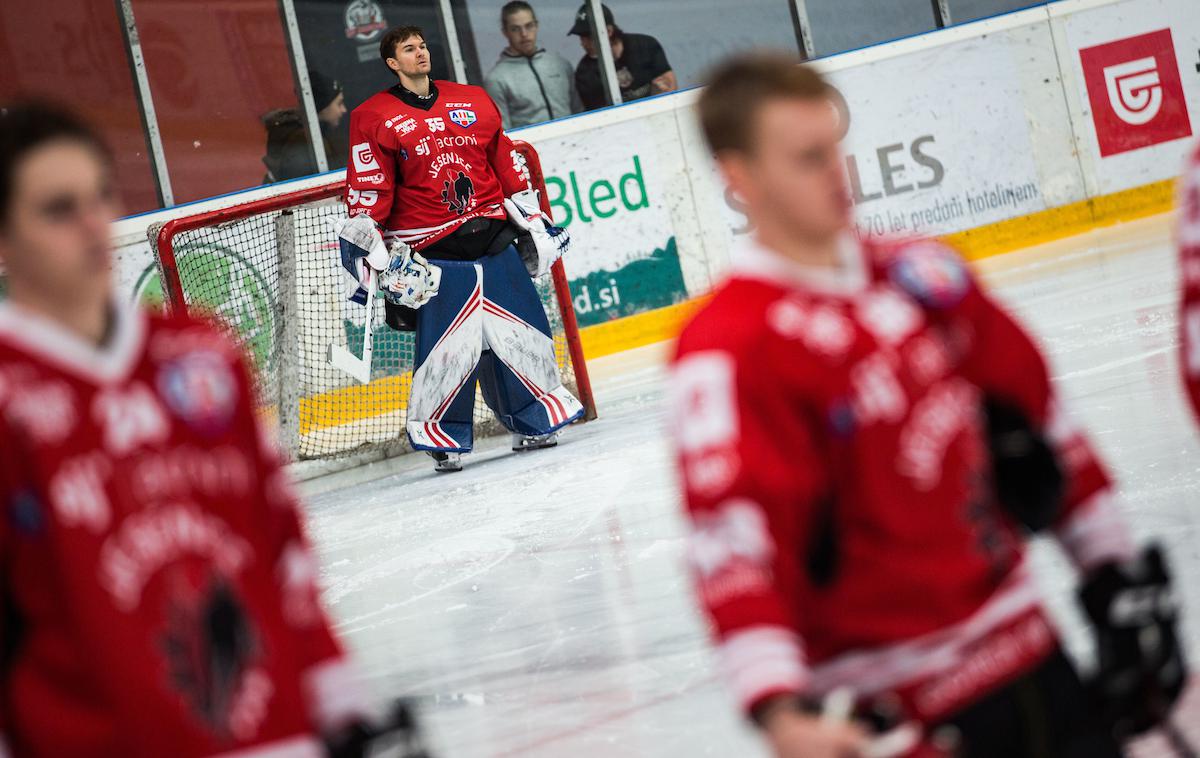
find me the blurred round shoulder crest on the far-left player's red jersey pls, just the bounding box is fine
[158,350,238,435]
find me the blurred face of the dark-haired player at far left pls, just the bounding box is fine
[0,139,118,302]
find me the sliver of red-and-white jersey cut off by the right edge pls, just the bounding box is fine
[1178,144,1200,421]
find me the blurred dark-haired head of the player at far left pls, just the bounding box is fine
[0,102,118,305]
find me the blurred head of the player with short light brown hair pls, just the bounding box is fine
[698,54,852,250]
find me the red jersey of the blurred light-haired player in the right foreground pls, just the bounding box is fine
[668,237,1132,721]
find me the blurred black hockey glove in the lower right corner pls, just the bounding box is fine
[1080,546,1187,739]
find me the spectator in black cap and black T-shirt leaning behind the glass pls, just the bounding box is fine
[568,4,679,110]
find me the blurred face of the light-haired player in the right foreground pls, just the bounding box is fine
[720,98,853,241]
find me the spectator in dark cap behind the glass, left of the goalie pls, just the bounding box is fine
[263,70,346,185]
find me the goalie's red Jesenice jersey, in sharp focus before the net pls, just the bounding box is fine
[346,82,529,249]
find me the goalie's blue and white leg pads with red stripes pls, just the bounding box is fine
[408,246,583,452]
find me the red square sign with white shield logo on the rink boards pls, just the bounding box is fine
[1079,29,1192,157]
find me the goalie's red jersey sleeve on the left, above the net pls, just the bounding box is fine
[346,110,400,228]
